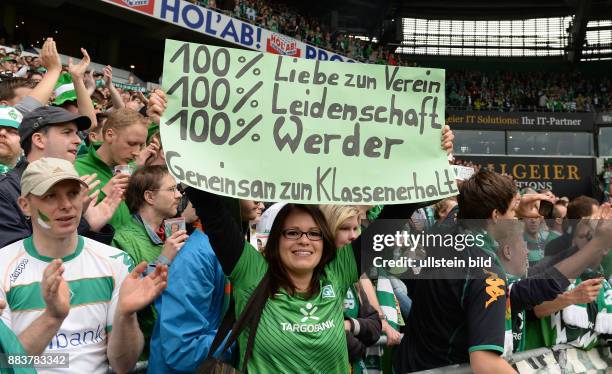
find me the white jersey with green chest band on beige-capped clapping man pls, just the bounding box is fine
[0,236,133,374]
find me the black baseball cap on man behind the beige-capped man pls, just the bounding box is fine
[19,106,91,146]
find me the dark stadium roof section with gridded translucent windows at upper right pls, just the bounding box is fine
[391,0,612,63]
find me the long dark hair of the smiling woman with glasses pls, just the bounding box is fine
[265,204,336,299]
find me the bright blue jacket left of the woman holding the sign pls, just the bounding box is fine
[148,230,229,374]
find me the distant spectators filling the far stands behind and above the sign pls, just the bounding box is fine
[196,0,612,112]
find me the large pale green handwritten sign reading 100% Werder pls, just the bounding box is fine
[161,40,456,204]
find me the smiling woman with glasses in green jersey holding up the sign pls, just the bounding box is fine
[187,127,453,373]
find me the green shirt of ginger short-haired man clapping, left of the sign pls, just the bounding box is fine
[74,143,132,230]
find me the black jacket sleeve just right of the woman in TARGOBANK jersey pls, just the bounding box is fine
[345,290,382,363]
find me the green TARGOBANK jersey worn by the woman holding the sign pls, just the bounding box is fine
[230,243,357,374]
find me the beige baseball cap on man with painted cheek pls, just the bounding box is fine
[21,157,87,196]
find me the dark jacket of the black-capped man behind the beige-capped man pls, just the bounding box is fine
[0,160,115,248]
